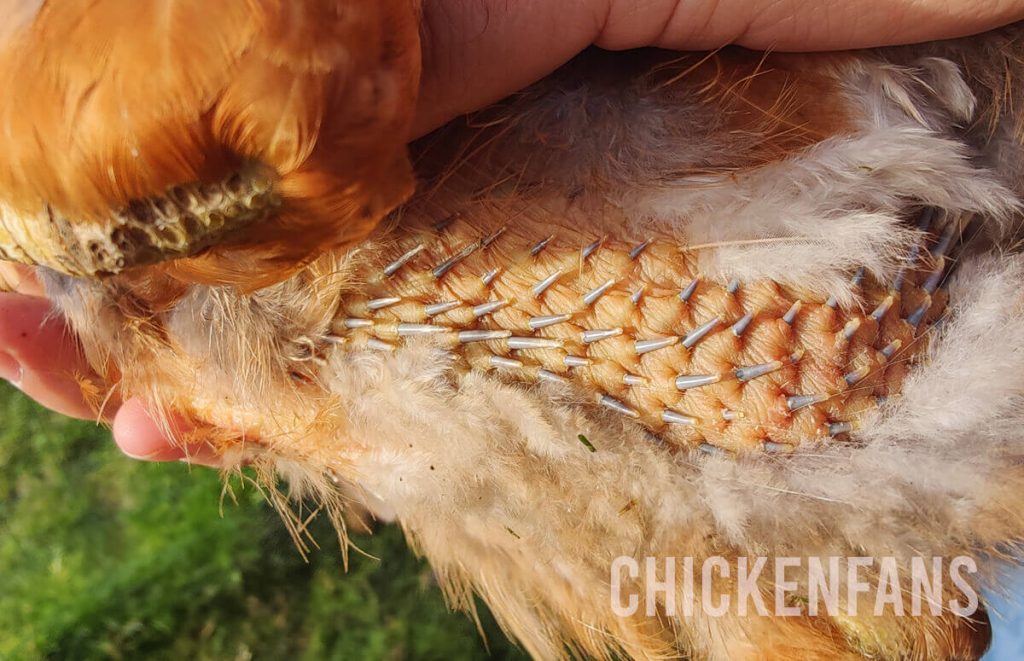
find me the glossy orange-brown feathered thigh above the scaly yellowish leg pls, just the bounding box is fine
[0,0,419,287]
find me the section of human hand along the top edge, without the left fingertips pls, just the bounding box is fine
[415,0,1024,135]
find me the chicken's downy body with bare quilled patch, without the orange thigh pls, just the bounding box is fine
[34,36,1024,659]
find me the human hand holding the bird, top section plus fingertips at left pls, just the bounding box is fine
[0,0,1024,462]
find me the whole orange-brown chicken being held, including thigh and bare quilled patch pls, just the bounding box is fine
[6,2,1024,659]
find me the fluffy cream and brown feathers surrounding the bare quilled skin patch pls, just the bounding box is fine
[36,27,1024,659]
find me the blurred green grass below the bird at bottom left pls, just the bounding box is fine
[0,384,522,661]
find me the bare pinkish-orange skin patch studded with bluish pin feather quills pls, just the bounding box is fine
[334,196,942,451]
